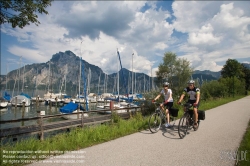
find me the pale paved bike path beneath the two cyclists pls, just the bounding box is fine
[31,96,250,166]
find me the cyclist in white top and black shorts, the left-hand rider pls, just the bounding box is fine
[153,82,174,127]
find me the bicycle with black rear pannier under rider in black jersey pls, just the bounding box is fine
[178,103,205,139]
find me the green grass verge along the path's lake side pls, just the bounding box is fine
[0,96,250,165]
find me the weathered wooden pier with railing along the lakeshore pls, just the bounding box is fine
[0,106,145,141]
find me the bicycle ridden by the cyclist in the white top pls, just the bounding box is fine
[148,102,179,133]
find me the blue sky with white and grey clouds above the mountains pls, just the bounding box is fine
[1,1,250,76]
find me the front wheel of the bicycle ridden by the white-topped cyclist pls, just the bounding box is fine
[148,113,162,133]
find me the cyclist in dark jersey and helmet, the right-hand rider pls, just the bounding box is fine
[178,80,200,130]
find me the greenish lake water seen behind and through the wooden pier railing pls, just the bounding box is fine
[0,102,109,144]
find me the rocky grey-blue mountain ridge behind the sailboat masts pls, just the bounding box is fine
[1,51,150,95]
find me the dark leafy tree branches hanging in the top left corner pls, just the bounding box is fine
[0,0,52,28]
